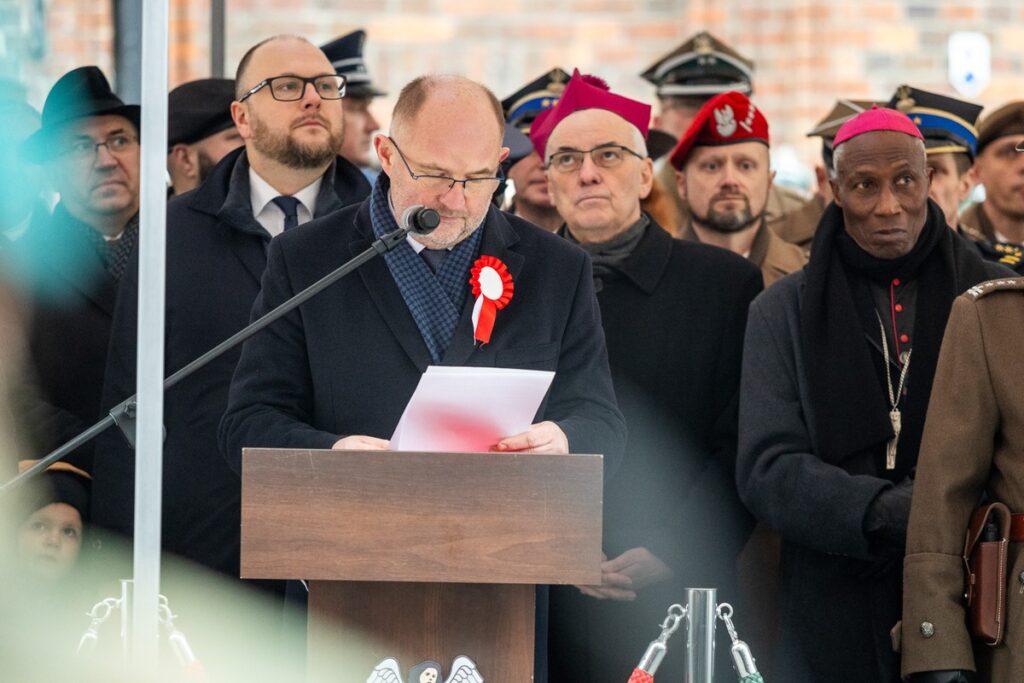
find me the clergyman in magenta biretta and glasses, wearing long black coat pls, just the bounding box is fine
[530,72,762,683]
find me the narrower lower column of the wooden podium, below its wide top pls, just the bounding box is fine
[307,581,536,683]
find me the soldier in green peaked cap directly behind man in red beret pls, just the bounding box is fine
[640,31,807,244]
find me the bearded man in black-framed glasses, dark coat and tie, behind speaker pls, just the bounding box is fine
[93,36,370,578]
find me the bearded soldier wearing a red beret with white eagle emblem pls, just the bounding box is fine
[669,91,807,287]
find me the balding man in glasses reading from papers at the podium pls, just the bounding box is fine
[220,76,626,476]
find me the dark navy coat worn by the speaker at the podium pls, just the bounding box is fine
[220,197,626,476]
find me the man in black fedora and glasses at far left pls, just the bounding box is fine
[15,67,139,479]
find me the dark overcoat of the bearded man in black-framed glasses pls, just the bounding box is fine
[92,150,370,577]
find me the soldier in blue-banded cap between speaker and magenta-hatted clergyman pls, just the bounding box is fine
[502,67,569,231]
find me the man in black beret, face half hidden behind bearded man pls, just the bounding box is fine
[167,78,242,195]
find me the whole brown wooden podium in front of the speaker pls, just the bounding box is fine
[242,449,602,683]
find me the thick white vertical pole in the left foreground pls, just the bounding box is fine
[132,0,168,674]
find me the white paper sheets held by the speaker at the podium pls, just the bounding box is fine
[390,366,555,453]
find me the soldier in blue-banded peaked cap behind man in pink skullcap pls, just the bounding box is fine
[889,85,1022,269]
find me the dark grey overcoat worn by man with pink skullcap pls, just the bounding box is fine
[737,227,1013,683]
